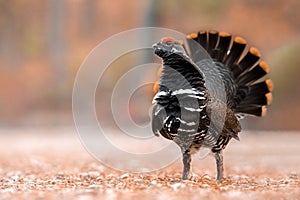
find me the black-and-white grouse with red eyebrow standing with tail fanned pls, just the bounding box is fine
[152,31,273,181]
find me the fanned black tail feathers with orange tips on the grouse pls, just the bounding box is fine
[187,31,273,116]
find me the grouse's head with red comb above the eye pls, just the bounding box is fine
[152,37,187,59]
